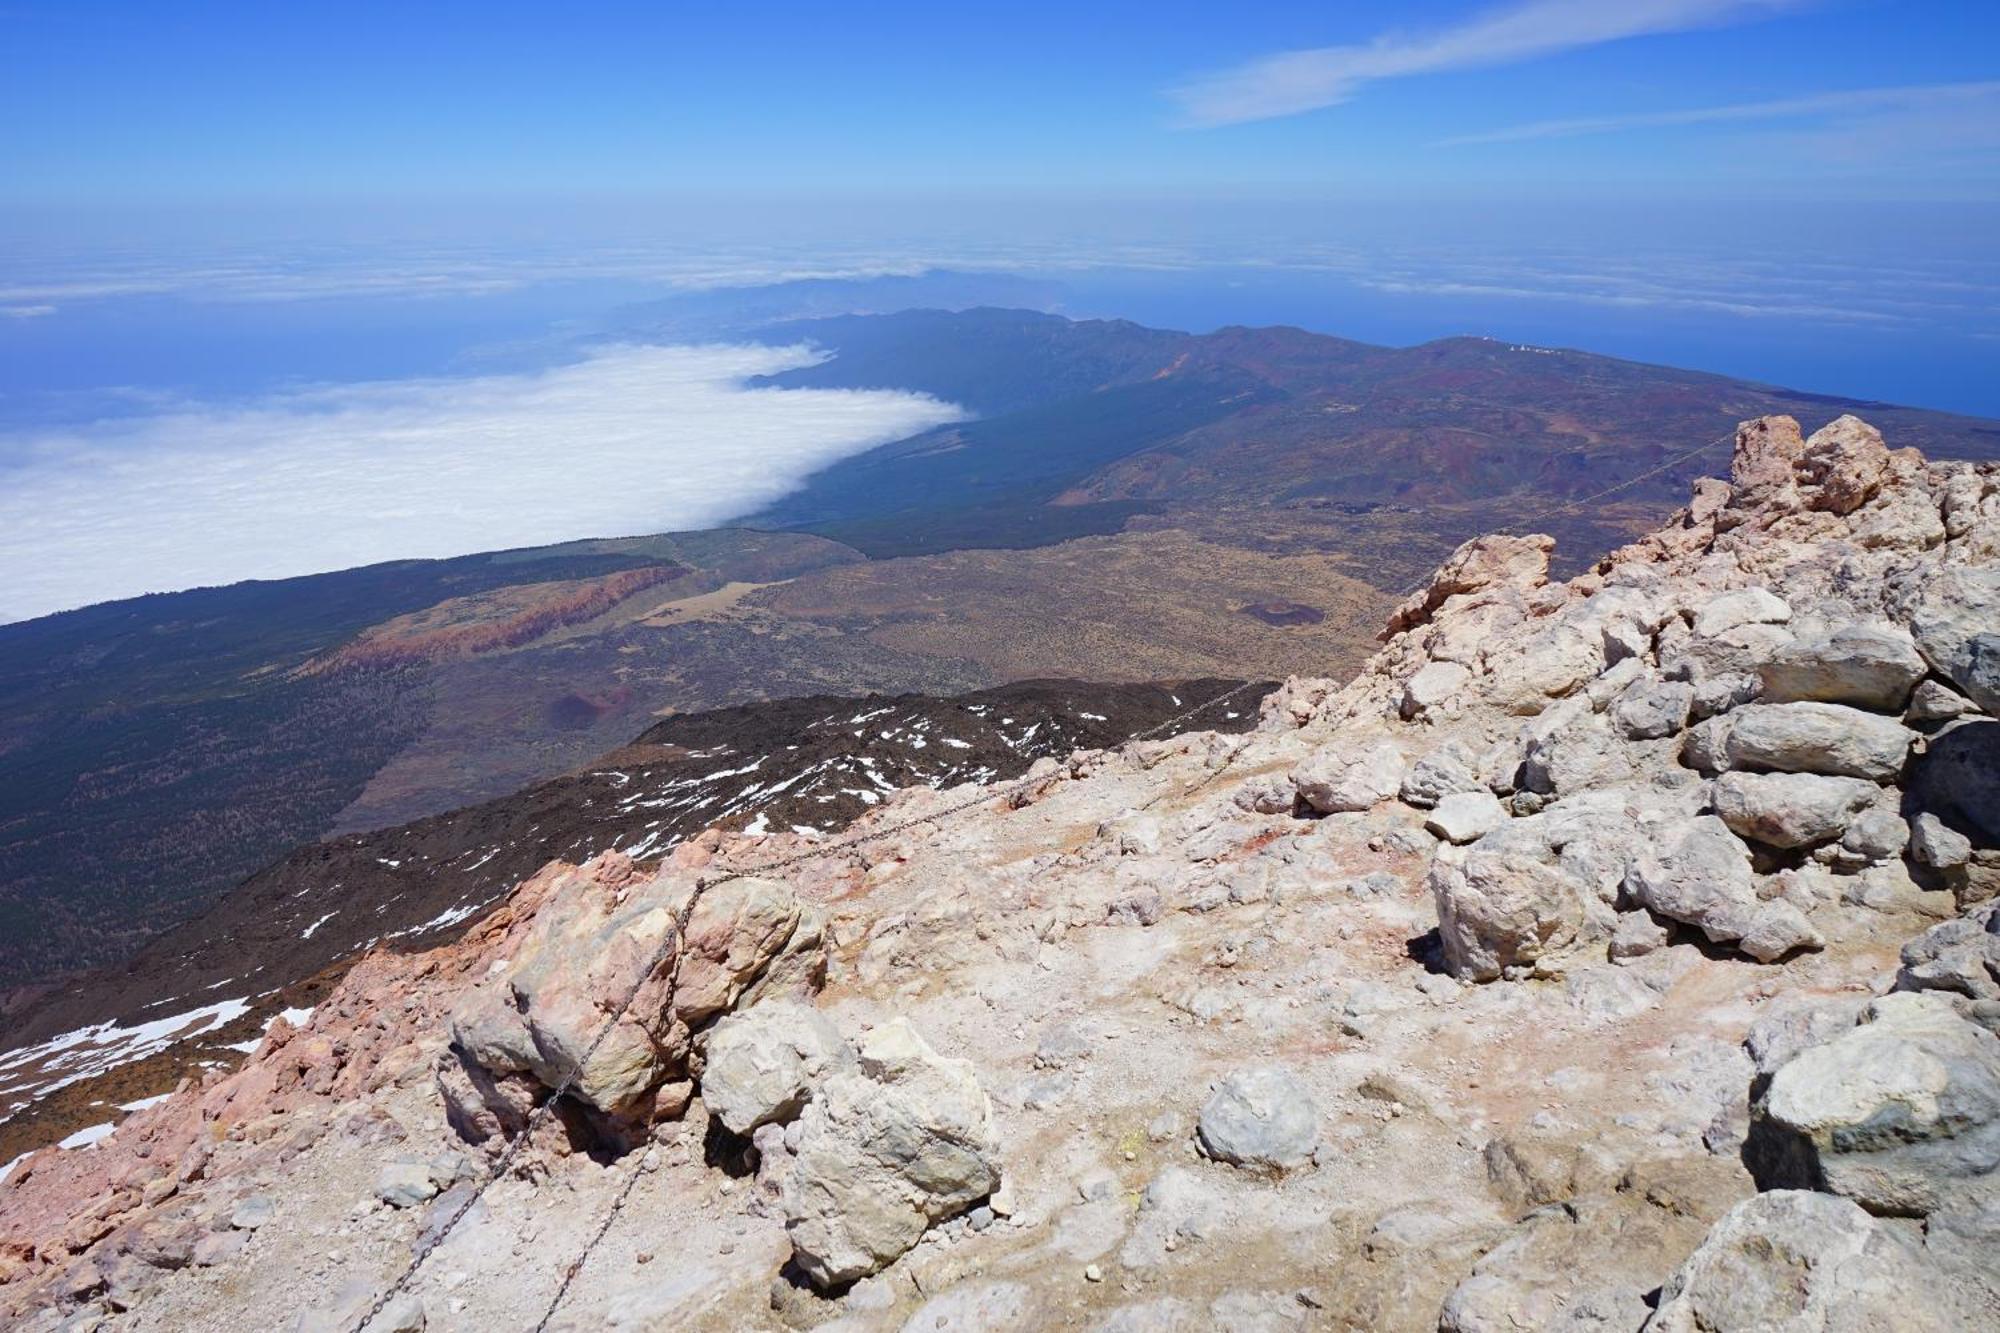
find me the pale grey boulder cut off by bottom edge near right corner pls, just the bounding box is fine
[1646,1189,1958,1333]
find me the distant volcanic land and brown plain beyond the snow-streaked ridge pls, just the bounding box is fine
[0,306,2000,987]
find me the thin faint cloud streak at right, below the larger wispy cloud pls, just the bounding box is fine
[1442,80,2000,144]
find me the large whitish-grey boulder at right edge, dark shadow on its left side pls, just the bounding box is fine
[1746,991,2000,1215]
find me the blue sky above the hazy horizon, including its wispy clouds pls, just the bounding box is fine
[0,0,2000,208]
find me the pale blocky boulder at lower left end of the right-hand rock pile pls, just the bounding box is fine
[1426,835,1584,981]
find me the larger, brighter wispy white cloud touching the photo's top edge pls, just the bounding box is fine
[1168,0,1804,126]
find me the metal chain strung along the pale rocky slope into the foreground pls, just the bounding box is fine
[354,432,1734,1333]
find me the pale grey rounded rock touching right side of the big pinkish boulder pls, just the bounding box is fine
[702,1001,846,1135]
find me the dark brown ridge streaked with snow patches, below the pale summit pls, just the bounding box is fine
[0,681,1270,1161]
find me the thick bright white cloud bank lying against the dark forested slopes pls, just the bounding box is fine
[0,346,962,620]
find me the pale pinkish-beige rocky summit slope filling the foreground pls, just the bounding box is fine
[0,416,2000,1333]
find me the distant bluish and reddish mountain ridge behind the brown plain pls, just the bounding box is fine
[748,310,2000,556]
